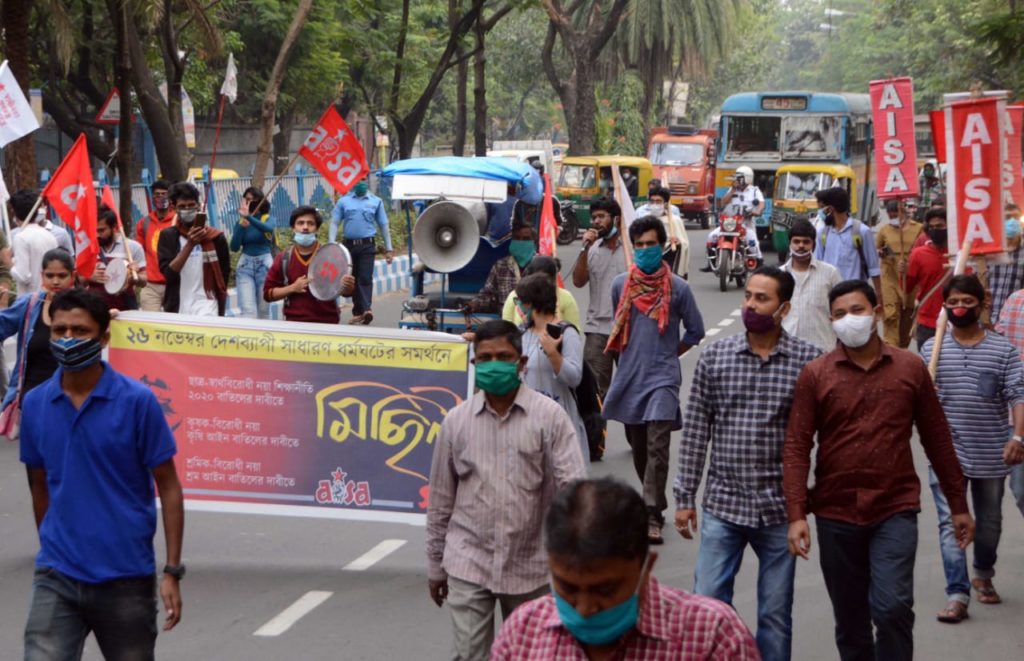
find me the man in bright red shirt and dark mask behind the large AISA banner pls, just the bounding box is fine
[905,209,950,351]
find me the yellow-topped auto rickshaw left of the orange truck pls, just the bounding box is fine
[555,156,651,246]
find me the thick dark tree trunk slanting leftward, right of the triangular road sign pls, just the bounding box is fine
[124,10,188,181]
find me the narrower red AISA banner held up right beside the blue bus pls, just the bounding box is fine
[869,78,921,200]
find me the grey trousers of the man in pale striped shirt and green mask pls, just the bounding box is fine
[447,576,550,661]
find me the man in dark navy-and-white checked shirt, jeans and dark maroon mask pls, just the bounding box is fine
[674,266,821,661]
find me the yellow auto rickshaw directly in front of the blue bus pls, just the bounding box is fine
[771,164,857,263]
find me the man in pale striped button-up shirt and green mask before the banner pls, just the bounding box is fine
[427,320,586,661]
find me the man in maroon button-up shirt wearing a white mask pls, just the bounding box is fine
[782,280,974,661]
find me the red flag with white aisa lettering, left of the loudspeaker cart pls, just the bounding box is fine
[299,105,370,194]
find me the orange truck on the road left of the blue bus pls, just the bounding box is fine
[647,126,718,229]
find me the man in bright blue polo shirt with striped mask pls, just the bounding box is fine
[20,290,185,660]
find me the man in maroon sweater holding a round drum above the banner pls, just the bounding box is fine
[263,207,355,323]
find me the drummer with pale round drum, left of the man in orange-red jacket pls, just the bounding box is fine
[86,205,145,310]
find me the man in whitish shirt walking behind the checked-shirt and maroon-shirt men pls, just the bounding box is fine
[782,220,843,351]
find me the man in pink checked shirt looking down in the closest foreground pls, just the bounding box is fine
[490,478,761,661]
